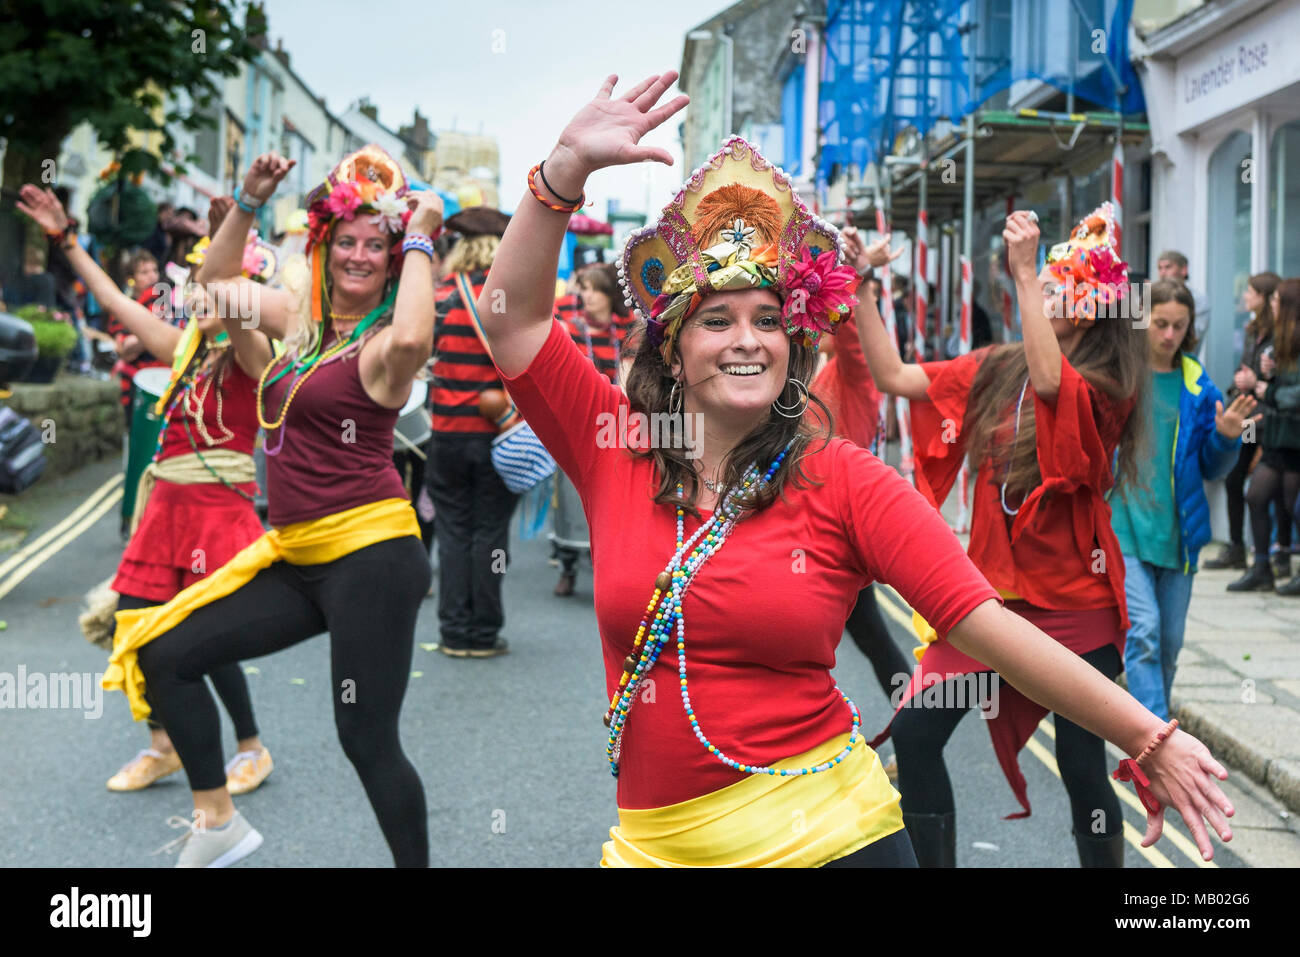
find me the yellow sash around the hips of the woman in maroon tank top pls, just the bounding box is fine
[103,498,420,720]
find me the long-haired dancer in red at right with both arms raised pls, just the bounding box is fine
[859,204,1149,867]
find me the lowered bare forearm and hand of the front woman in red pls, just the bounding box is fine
[948,601,1234,861]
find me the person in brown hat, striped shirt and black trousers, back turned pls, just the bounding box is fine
[425,205,519,658]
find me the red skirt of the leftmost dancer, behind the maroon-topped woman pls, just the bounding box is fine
[113,481,264,603]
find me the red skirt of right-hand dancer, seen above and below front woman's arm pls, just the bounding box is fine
[871,601,1125,819]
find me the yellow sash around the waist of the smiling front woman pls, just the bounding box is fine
[601,732,902,867]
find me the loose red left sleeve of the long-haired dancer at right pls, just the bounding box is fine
[911,346,992,508]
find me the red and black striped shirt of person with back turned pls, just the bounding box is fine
[433,272,504,436]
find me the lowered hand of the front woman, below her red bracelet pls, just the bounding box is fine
[1141,731,1234,861]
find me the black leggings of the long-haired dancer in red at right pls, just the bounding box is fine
[893,645,1123,837]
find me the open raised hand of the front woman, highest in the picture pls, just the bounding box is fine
[556,70,690,177]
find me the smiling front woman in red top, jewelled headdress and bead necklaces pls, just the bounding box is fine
[480,73,1232,866]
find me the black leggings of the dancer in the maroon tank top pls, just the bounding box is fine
[139,536,432,867]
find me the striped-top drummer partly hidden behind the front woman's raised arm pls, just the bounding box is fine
[551,263,629,598]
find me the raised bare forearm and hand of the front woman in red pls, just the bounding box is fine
[478,70,688,377]
